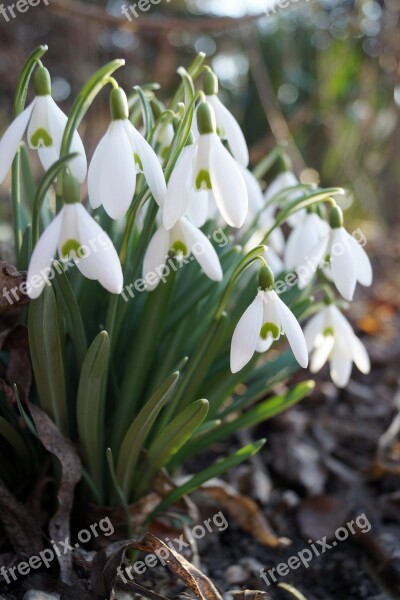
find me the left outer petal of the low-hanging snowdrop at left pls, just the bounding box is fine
[26,209,64,300]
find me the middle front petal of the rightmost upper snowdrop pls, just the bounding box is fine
[330,227,357,300]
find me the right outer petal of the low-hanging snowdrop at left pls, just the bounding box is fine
[72,204,123,294]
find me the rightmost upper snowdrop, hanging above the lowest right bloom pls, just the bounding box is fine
[297,206,372,300]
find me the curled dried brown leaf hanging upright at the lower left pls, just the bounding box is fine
[29,404,82,584]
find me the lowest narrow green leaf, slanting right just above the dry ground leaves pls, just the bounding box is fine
[147,439,266,523]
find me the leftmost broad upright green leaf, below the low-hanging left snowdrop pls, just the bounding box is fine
[28,285,68,434]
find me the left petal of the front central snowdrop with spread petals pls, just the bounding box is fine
[163,146,194,229]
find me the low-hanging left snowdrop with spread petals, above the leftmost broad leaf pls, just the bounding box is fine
[27,174,123,299]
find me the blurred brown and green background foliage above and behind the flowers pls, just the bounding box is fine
[0,0,400,242]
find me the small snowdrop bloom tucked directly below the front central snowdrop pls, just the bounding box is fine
[143,217,223,291]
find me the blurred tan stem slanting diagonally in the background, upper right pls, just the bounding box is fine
[240,25,306,172]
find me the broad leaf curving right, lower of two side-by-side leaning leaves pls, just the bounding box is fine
[138,400,208,495]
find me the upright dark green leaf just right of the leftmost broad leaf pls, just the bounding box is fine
[76,331,109,497]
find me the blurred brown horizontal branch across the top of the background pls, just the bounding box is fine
[48,0,266,34]
